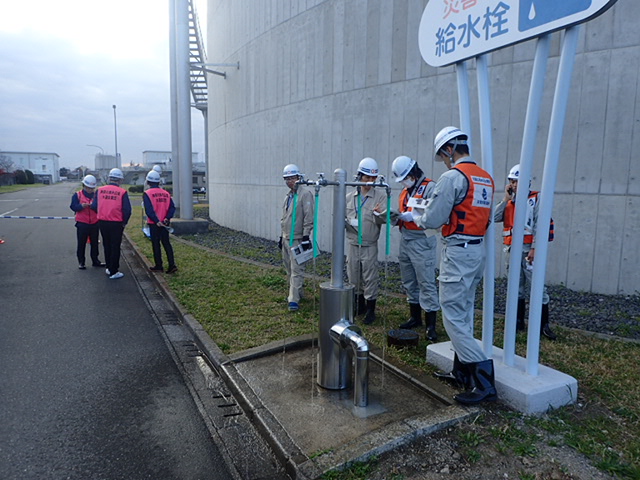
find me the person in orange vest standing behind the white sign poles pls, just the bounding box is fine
[493,164,557,340]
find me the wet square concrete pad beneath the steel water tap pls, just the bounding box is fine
[228,342,475,478]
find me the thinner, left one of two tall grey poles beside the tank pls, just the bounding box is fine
[169,0,181,216]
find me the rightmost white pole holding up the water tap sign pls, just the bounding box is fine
[527,26,579,376]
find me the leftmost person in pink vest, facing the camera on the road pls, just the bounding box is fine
[69,175,106,270]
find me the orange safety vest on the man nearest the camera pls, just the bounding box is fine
[442,162,495,237]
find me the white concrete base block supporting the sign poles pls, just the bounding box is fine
[427,342,578,415]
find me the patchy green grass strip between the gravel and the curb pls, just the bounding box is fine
[122,212,640,480]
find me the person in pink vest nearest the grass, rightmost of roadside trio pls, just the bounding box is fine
[142,170,178,273]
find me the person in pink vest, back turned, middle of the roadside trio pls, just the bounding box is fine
[91,168,131,280]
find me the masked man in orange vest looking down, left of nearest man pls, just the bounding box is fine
[391,155,440,342]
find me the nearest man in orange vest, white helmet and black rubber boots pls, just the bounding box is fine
[414,127,498,405]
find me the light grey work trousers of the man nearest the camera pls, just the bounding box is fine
[438,243,487,363]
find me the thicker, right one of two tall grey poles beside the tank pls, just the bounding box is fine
[176,0,193,220]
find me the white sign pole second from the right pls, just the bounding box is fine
[503,35,551,366]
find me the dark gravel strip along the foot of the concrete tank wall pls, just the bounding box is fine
[184,218,640,340]
